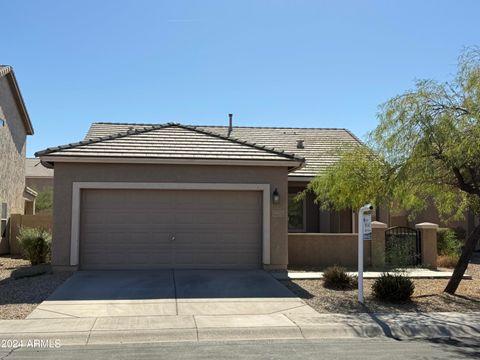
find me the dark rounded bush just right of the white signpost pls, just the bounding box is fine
[372,274,415,302]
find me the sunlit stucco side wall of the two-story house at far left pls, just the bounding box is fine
[0,76,26,214]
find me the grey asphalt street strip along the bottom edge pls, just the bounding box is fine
[0,339,480,360]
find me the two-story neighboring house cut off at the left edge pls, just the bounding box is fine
[0,65,36,253]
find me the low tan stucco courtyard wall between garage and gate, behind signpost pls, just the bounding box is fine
[288,233,371,267]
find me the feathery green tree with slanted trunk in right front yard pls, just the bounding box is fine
[310,48,480,292]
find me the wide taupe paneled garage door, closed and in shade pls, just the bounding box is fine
[80,189,262,269]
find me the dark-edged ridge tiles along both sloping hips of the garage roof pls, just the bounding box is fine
[34,123,305,161]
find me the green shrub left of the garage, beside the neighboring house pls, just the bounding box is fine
[17,227,52,265]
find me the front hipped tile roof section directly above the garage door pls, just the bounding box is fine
[35,123,303,167]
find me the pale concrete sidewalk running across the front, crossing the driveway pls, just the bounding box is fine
[0,310,480,346]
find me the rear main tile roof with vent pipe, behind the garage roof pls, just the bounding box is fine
[85,123,361,178]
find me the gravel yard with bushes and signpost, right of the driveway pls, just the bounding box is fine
[283,253,480,313]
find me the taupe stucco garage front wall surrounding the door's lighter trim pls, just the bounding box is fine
[52,163,288,268]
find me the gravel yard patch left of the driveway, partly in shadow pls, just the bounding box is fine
[0,256,70,319]
